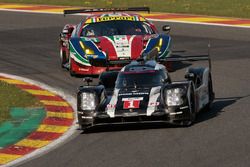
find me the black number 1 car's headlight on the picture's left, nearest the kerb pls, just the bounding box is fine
[81,92,96,110]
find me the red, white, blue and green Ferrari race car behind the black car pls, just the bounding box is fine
[59,7,171,75]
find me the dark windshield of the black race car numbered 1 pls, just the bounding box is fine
[116,70,166,88]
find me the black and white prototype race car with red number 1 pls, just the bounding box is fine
[77,49,214,129]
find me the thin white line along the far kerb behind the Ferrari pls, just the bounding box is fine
[0,9,250,28]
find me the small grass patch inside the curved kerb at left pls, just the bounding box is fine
[0,81,43,123]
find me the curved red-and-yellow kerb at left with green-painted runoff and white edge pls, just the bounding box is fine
[0,73,75,166]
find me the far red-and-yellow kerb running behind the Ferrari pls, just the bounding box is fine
[0,3,250,28]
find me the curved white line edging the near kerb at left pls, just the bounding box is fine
[0,73,77,167]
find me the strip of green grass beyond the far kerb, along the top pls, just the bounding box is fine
[0,0,250,18]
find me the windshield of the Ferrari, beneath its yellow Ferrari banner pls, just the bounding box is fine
[81,20,155,37]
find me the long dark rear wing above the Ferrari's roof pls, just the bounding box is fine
[63,7,150,15]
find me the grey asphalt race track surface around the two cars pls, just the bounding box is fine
[0,11,250,167]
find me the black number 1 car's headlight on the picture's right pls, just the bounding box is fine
[166,88,183,106]
